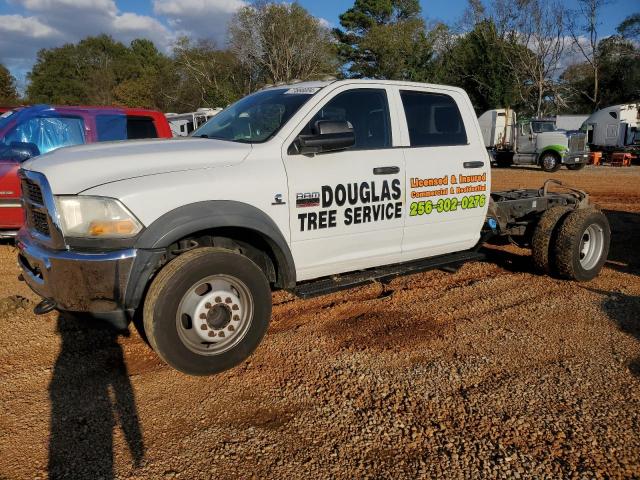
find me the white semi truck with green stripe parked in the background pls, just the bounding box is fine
[478,108,589,172]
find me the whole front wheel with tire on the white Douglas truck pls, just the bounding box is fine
[143,248,271,375]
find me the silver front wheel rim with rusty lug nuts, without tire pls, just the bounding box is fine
[176,275,253,355]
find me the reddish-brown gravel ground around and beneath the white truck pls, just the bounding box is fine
[0,167,640,479]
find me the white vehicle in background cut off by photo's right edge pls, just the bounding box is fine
[582,103,640,152]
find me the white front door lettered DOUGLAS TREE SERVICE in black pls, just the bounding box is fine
[282,84,404,280]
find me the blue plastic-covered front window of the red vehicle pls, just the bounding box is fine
[4,117,85,154]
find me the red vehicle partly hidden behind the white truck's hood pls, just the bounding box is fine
[0,105,172,238]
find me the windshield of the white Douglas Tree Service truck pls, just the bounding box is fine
[193,87,319,143]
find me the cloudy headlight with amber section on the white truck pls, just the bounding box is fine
[56,195,142,238]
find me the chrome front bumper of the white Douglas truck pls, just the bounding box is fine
[16,228,136,327]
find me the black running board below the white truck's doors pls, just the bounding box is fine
[292,251,485,298]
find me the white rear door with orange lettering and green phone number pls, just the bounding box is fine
[397,87,490,260]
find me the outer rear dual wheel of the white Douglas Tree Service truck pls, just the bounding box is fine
[555,208,611,282]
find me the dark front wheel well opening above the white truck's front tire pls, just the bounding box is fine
[167,227,291,288]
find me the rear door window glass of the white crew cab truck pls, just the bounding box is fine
[400,90,467,147]
